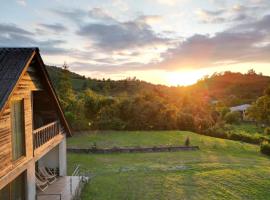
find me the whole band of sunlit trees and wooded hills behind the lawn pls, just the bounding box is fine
[54,65,270,147]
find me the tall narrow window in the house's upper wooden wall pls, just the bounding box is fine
[11,100,25,160]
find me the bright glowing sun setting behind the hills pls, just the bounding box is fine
[167,71,205,86]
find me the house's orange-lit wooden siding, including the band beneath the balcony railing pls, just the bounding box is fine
[0,57,65,190]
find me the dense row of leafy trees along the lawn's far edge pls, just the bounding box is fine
[55,65,214,131]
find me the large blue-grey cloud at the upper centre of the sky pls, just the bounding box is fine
[77,12,168,51]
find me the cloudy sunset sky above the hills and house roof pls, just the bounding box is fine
[0,0,270,85]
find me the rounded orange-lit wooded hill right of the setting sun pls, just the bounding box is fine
[189,72,270,106]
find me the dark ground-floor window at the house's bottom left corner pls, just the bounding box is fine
[0,173,25,200]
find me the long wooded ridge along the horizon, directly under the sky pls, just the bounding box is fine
[47,66,270,106]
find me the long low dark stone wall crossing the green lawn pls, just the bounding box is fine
[67,146,199,154]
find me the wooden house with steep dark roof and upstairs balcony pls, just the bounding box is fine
[0,48,86,200]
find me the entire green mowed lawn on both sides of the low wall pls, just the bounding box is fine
[68,131,270,200]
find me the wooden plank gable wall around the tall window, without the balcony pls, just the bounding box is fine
[0,69,38,177]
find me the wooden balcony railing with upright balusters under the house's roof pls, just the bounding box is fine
[33,121,61,149]
